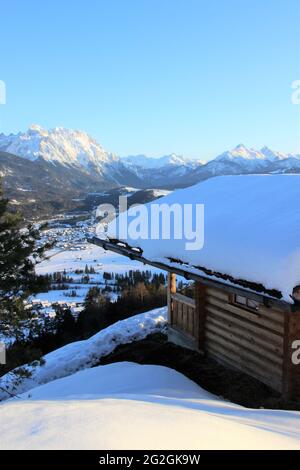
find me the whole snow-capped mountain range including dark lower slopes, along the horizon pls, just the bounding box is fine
[0,125,300,217]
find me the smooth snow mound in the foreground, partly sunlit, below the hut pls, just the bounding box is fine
[0,362,300,450]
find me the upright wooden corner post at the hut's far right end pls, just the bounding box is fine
[282,310,300,401]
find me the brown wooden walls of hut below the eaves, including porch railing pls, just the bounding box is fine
[168,277,300,400]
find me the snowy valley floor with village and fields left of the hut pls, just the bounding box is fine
[27,211,159,318]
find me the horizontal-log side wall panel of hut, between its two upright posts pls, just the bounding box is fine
[205,288,285,391]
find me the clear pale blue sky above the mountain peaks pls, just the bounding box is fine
[0,0,300,159]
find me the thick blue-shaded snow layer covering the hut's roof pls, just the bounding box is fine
[108,175,300,302]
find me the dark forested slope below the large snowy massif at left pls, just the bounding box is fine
[0,152,113,218]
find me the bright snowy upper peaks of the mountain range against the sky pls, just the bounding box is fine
[0,124,300,188]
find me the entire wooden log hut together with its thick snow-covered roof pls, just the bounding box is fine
[92,175,300,400]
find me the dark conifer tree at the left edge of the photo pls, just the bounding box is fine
[0,182,50,396]
